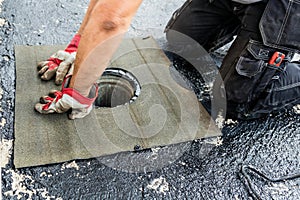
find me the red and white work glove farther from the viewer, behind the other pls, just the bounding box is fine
[38,34,80,85]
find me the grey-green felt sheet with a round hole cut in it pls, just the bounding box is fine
[14,40,221,168]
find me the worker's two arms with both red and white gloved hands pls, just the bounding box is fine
[35,0,142,119]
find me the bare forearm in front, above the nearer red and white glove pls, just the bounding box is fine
[70,0,142,95]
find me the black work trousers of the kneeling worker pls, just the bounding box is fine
[166,0,300,118]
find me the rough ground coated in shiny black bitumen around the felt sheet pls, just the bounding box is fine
[0,0,300,199]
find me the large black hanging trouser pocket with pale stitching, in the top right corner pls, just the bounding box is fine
[259,0,300,50]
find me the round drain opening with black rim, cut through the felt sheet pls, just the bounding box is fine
[95,68,141,108]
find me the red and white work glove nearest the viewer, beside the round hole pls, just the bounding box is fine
[35,76,98,119]
